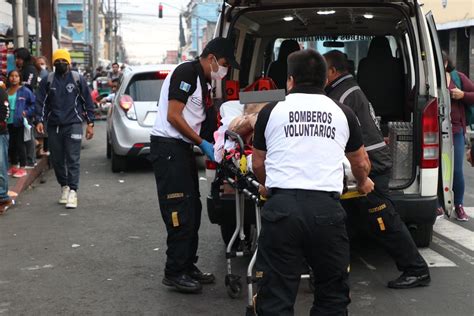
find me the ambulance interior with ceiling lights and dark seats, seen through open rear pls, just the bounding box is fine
[229,6,421,189]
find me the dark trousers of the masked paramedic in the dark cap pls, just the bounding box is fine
[150,136,202,276]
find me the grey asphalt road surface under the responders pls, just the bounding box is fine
[0,123,474,315]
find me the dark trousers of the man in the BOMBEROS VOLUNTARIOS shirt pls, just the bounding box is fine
[256,189,350,315]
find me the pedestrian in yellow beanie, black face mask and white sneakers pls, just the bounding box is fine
[36,49,94,208]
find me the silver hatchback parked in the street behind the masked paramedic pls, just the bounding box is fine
[107,65,176,172]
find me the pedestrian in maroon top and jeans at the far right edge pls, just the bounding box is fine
[437,52,474,222]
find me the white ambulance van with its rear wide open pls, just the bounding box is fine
[207,0,453,246]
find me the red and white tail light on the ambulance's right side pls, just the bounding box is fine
[421,99,439,168]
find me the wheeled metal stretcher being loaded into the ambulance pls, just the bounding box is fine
[216,94,361,315]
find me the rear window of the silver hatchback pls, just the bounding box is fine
[125,72,163,102]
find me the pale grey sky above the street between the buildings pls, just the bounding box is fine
[117,0,189,64]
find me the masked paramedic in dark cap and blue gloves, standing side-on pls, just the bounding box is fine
[150,38,239,293]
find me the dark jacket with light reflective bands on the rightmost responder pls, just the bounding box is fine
[326,74,392,174]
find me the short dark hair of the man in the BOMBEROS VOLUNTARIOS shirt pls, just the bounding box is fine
[288,49,327,89]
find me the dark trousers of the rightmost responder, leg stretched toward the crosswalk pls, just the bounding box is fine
[343,173,428,275]
